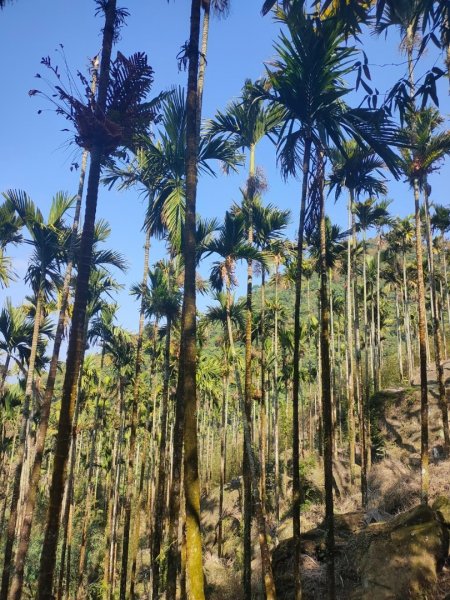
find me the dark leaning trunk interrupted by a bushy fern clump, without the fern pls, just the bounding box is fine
[37,0,116,600]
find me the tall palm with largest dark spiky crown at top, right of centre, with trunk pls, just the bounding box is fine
[260,3,396,599]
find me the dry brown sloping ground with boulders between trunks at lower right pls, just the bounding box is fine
[202,360,450,600]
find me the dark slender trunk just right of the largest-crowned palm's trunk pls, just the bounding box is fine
[319,159,336,600]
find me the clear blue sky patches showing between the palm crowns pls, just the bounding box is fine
[0,0,450,344]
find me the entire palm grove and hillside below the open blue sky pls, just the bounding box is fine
[0,0,450,600]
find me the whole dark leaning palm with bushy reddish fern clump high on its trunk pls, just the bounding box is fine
[37,0,165,600]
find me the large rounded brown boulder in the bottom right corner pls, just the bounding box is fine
[345,506,449,600]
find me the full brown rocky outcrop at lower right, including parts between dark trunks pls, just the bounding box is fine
[273,504,450,600]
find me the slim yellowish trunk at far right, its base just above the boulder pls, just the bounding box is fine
[413,179,430,504]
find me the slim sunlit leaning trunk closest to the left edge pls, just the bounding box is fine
[0,288,44,600]
